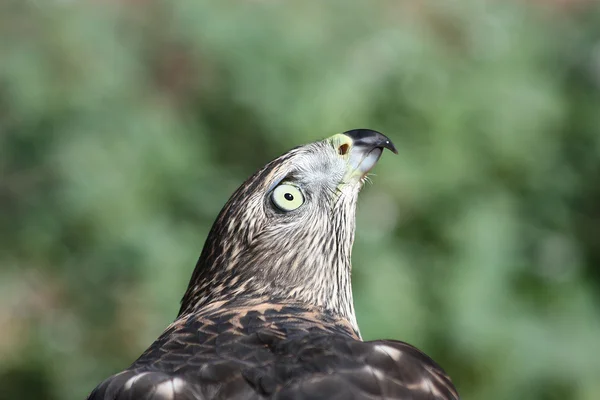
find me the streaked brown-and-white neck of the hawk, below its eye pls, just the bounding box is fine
[179,209,359,333]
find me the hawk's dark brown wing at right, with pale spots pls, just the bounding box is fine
[274,335,459,400]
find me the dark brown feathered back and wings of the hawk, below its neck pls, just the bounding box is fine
[89,316,458,400]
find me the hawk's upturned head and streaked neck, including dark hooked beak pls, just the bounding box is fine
[180,129,397,323]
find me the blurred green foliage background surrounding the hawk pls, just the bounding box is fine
[0,0,600,400]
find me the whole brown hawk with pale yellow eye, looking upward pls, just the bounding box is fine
[88,129,459,400]
